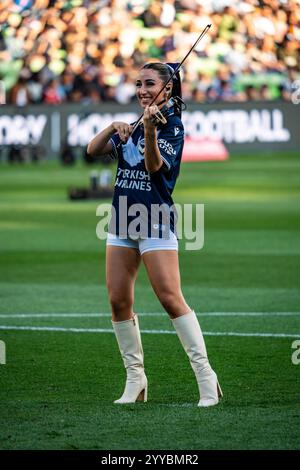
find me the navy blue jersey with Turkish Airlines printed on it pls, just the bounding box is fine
[109,113,184,238]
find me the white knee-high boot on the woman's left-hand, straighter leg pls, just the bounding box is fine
[112,315,148,404]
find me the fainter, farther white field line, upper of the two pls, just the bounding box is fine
[0,312,300,318]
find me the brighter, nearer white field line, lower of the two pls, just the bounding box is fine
[0,325,300,338]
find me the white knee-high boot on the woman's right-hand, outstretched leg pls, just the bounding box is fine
[172,312,222,406]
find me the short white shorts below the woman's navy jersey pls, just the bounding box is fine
[106,232,178,255]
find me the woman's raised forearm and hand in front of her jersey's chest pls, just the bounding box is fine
[143,106,163,173]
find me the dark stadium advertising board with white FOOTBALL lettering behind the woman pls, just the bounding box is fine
[0,101,300,157]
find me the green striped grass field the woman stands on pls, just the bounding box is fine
[0,154,300,450]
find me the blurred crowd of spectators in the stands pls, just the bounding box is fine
[0,0,300,106]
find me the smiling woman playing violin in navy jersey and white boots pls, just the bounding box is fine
[87,62,222,406]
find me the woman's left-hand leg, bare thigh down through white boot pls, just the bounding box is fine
[106,246,148,404]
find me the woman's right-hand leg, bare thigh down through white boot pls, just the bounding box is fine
[143,250,222,406]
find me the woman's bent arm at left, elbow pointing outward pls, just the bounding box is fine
[87,121,132,156]
